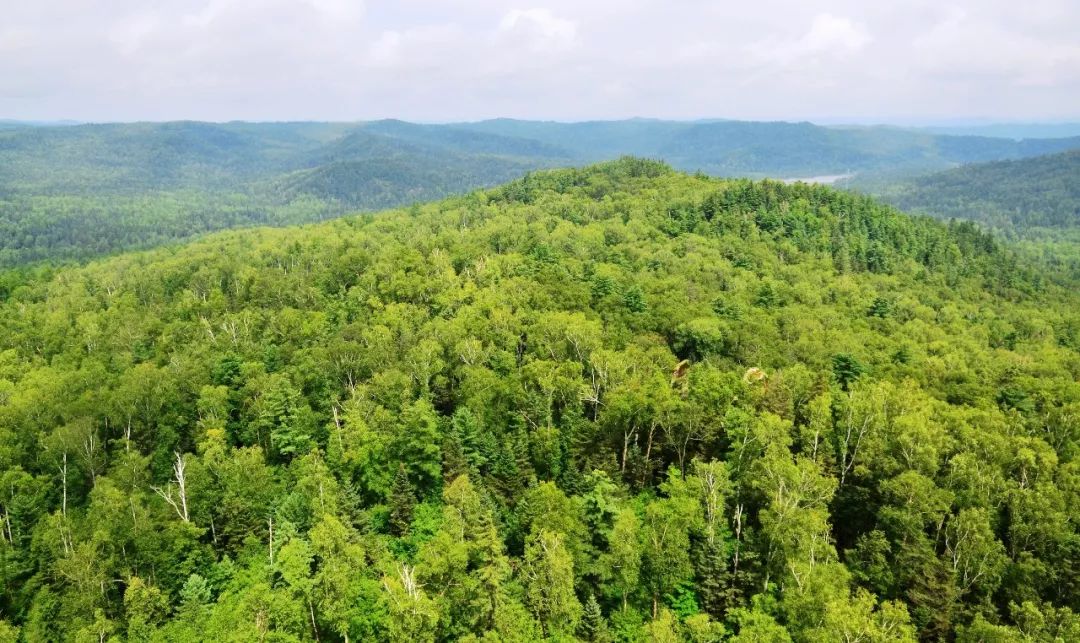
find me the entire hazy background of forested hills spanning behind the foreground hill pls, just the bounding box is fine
[0,119,1080,268]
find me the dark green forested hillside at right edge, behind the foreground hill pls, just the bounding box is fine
[880,149,1080,230]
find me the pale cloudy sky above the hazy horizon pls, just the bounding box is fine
[0,0,1080,124]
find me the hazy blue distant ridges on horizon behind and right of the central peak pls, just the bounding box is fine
[447,119,1080,177]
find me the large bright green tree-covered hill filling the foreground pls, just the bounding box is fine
[0,159,1080,642]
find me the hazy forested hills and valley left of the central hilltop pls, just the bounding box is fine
[0,122,565,268]
